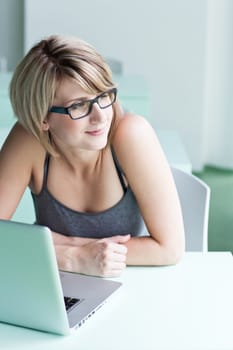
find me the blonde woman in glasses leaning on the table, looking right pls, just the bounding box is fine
[0,36,184,277]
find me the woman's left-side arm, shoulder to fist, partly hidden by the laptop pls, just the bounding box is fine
[0,124,130,277]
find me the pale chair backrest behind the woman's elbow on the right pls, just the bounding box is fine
[171,168,210,251]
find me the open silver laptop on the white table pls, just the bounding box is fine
[0,220,121,335]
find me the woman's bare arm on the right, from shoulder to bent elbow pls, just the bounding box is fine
[113,115,185,265]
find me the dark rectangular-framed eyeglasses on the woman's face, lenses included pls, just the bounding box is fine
[49,88,117,120]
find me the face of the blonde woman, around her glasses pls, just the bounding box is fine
[44,78,113,150]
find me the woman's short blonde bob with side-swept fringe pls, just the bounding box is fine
[10,35,120,155]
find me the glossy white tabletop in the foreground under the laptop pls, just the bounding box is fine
[0,252,233,350]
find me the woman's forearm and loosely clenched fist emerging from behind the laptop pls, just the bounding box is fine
[53,232,130,277]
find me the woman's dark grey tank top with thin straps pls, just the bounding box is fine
[31,152,148,238]
